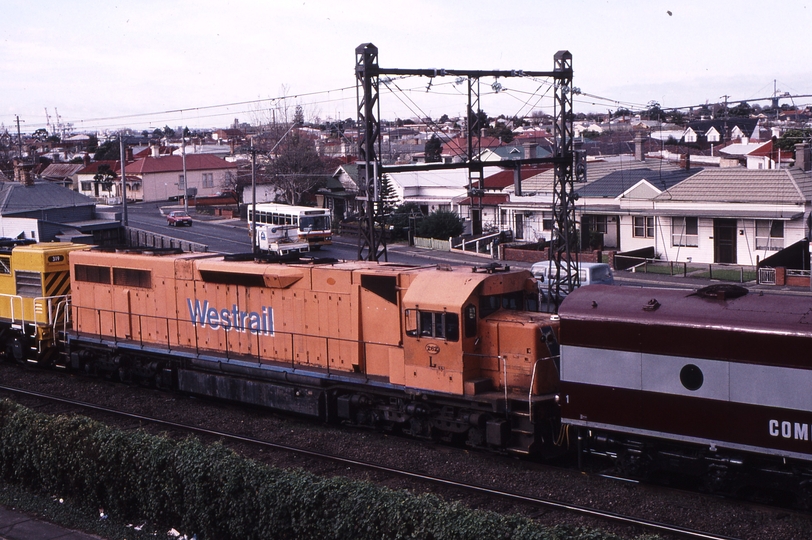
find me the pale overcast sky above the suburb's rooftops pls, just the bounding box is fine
[0,0,812,132]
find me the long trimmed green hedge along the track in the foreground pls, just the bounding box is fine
[0,401,636,540]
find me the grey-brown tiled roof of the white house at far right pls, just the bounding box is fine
[654,167,810,204]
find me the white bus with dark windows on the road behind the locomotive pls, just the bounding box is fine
[248,203,333,249]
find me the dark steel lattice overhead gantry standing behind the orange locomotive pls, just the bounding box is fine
[355,43,579,308]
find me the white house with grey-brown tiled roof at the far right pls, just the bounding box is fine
[636,157,812,265]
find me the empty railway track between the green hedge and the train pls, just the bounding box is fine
[0,386,734,540]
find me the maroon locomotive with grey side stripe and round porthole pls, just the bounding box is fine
[559,286,812,496]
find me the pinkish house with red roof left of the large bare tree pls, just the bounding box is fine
[125,154,237,202]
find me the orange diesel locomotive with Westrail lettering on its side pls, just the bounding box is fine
[67,249,559,454]
